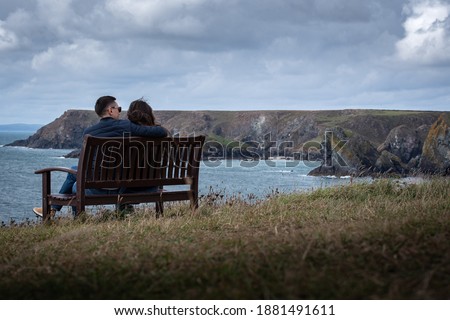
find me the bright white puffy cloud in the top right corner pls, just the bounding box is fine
[397,1,450,64]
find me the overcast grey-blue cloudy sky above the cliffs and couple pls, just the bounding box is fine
[0,0,450,124]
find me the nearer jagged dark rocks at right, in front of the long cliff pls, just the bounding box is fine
[310,113,450,176]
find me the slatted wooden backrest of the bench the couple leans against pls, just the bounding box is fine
[77,135,205,189]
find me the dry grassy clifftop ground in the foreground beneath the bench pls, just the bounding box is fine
[0,178,450,299]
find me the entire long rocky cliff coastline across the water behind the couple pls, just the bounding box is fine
[7,109,450,175]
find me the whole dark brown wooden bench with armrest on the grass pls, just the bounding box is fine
[35,135,205,221]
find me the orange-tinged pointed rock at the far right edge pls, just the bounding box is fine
[419,114,450,175]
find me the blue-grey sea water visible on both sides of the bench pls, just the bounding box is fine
[0,132,366,225]
